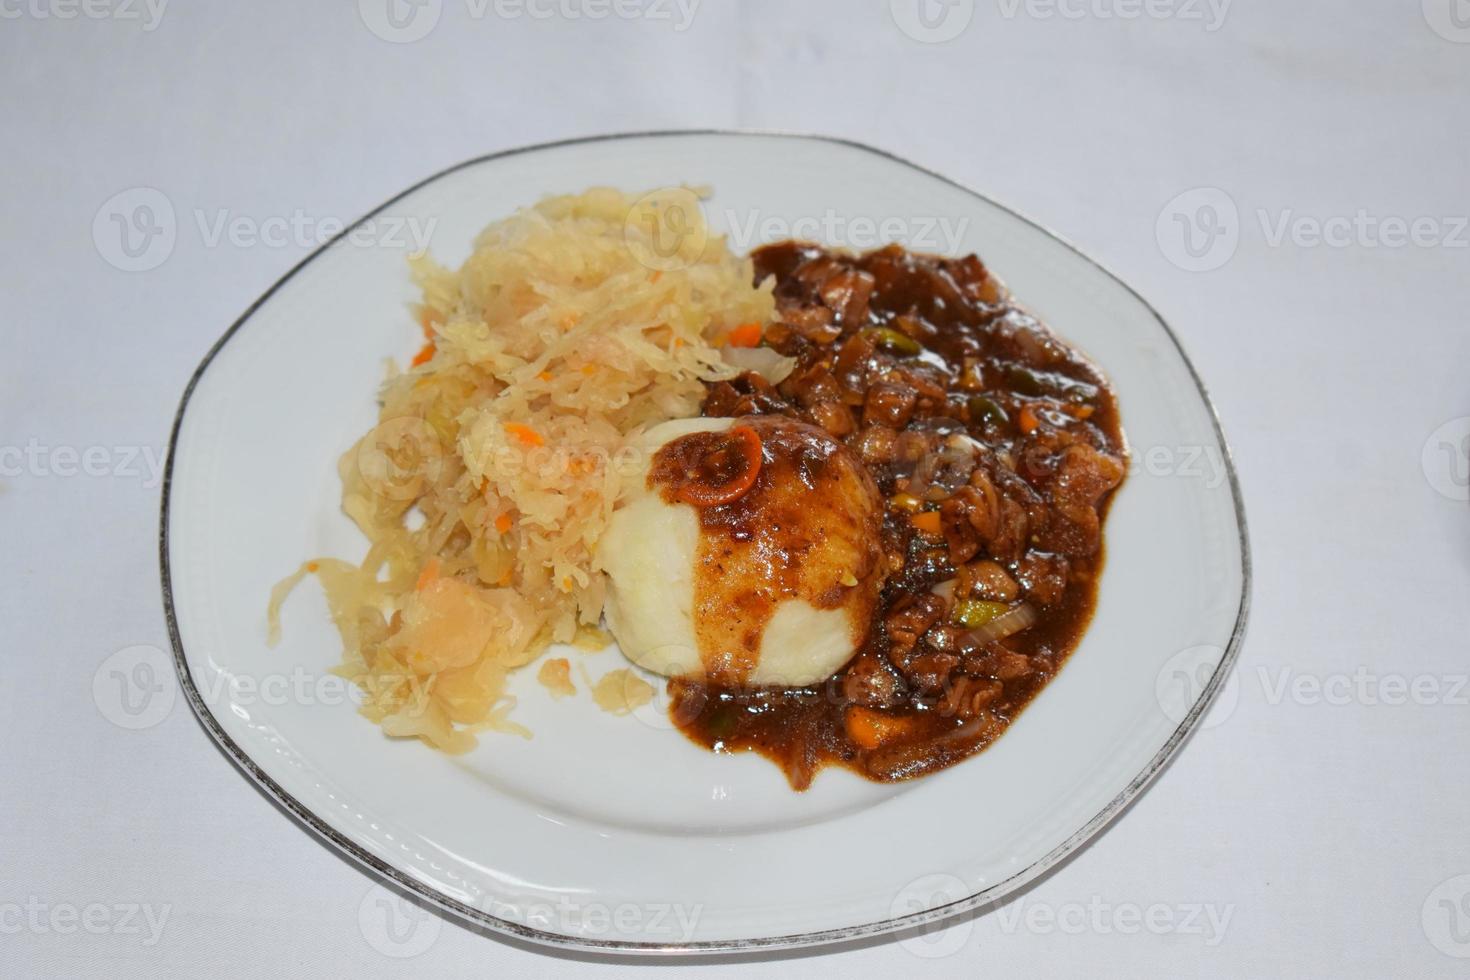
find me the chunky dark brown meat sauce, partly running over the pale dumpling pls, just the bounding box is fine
[662,242,1126,789]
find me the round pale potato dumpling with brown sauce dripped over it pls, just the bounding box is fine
[598,416,883,688]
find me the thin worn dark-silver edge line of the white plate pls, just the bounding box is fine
[159,128,1252,955]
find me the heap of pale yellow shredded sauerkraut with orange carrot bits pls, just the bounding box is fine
[269,188,773,752]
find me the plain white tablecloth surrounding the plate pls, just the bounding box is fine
[0,0,1470,979]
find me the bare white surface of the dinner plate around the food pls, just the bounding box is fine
[162,132,1248,952]
